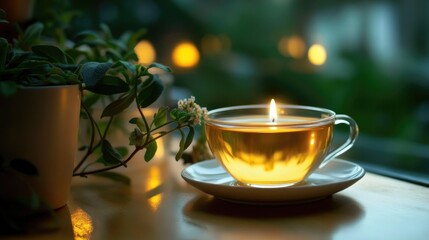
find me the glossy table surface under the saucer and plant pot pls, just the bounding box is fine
[4,152,429,240]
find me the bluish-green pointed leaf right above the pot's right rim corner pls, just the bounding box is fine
[80,62,112,88]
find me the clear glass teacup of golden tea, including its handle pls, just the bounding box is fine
[205,105,359,187]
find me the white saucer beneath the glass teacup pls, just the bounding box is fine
[182,159,365,204]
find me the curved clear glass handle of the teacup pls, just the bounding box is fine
[319,114,359,168]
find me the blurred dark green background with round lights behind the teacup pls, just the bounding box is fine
[1,0,429,186]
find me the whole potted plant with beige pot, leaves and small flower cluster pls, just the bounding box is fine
[0,8,206,232]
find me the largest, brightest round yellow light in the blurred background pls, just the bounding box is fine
[172,42,200,68]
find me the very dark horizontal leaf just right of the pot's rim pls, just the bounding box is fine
[88,75,130,95]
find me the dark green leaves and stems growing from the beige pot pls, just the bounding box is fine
[0,12,201,186]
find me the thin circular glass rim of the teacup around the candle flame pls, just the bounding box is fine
[205,104,336,128]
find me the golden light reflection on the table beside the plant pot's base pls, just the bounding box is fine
[71,208,93,240]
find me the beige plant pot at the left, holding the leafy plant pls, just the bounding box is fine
[0,85,80,209]
